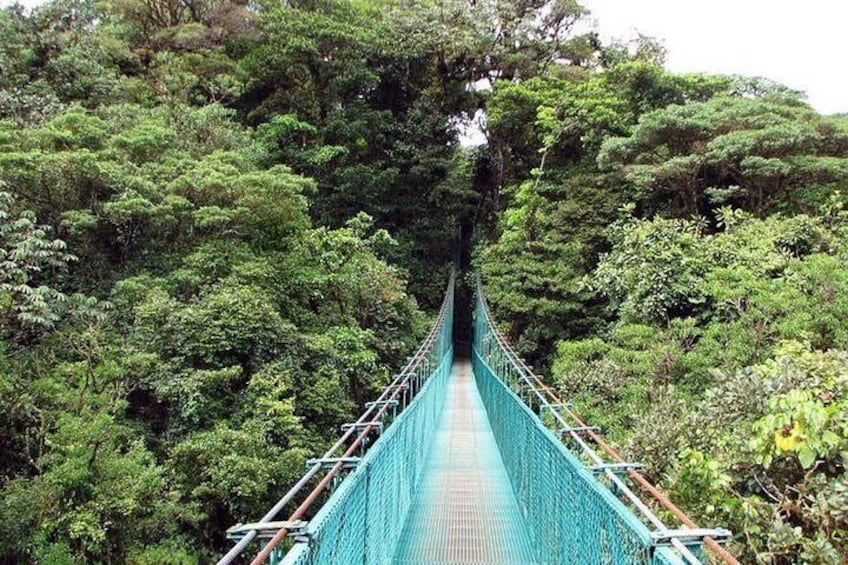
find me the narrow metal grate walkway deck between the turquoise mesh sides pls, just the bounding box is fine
[395,361,533,565]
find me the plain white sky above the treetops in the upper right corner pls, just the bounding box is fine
[580,0,848,114]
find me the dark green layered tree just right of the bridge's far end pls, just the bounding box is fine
[478,177,618,362]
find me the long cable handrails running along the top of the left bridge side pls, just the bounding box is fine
[218,271,456,565]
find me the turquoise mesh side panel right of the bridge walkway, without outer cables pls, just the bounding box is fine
[473,296,681,564]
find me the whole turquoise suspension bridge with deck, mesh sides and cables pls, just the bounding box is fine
[219,275,738,565]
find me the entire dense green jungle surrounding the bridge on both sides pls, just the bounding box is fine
[0,0,848,564]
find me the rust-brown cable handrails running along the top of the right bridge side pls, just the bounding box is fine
[477,277,739,565]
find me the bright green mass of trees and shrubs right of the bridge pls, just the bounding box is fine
[477,46,848,563]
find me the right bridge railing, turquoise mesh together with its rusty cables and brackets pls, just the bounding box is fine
[472,280,738,563]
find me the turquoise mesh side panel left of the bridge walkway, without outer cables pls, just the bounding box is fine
[283,344,453,565]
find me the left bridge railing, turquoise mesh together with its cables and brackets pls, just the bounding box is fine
[218,273,455,565]
